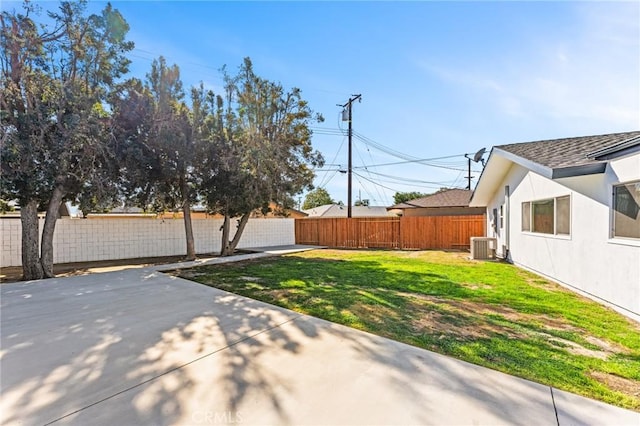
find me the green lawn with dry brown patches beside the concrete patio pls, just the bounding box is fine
[179,250,640,411]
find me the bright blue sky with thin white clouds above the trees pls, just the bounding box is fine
[3,1,640,205]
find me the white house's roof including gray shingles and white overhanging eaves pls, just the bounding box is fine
[469,131,640,207]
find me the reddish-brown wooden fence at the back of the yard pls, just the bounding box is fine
[296,215,486,250]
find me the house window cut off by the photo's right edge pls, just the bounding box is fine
[613,181,640,238]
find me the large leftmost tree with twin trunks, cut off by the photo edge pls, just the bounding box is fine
[0,1,133,279]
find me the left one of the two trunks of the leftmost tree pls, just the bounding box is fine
[20,200,43,280]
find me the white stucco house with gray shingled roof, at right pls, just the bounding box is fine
[469,131,640,320]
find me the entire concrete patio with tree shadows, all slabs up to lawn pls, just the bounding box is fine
[0,268,640,426]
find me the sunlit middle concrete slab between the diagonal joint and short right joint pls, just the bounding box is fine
[61,317,556,425]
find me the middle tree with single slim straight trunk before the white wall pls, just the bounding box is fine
[111,57,196,260]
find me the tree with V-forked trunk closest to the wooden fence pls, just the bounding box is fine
[193,58,323,256]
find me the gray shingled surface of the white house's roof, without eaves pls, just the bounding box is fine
[496,131,640,169]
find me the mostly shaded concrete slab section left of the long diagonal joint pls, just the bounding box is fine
[0,269,297,424]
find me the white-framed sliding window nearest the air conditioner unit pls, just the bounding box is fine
[522,195,571,235]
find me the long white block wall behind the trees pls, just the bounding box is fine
[0,219,295,266]
